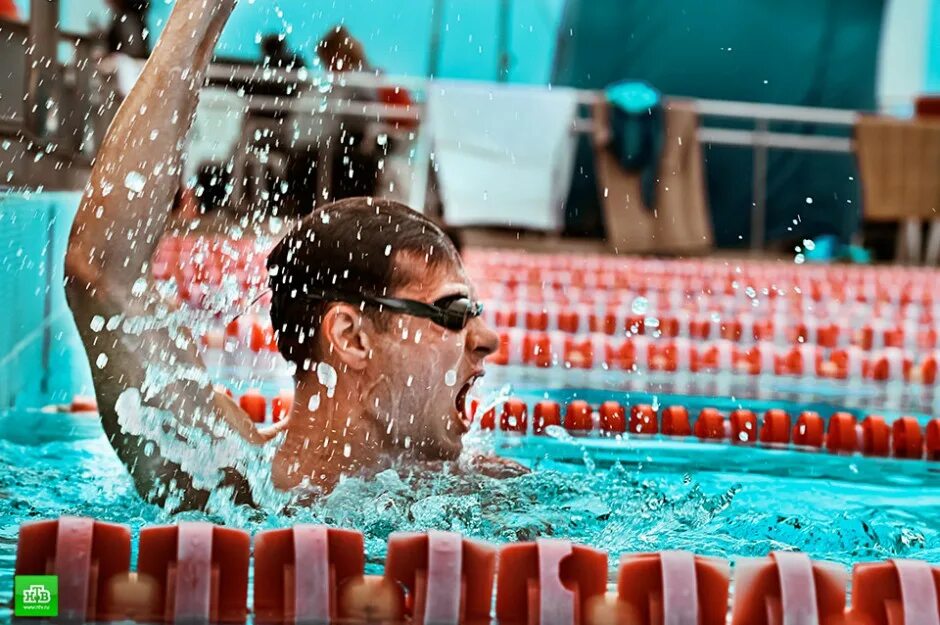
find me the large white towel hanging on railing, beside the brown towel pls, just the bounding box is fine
[428,82,577,231]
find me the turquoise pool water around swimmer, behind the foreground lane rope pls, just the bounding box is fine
[0,388,940,616]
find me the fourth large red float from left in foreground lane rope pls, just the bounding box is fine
[385,531,496,625]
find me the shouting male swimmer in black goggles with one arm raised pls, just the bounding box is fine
[65,0,518,508]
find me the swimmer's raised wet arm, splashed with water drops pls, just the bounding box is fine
[65,0,258,506]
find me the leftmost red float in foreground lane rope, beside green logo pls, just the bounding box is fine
[14,517,131,622]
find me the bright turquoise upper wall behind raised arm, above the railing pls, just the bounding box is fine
[146,0,564,83]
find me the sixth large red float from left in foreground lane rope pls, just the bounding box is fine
[617,551,731,625]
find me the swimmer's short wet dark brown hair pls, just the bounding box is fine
[267,197,460,370]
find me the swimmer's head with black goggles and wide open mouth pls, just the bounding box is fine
[268,198,497,459]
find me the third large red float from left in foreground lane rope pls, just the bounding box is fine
[254,525,365,623]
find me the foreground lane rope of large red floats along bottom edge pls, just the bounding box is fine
[15,517,940,625]
